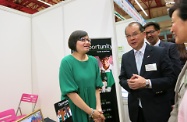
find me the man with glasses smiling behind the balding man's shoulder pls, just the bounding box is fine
[144,22,182,105]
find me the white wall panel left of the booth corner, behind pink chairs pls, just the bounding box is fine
[0,6,32,113]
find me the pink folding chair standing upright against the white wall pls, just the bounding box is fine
[16,93,38,115]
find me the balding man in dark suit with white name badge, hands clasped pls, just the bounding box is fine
[119,22,176,122]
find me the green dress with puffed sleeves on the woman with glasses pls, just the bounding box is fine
[59,55,103,122]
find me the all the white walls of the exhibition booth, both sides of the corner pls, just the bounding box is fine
[0,0,132,122]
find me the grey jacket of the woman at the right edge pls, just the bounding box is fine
[168,62,187,122]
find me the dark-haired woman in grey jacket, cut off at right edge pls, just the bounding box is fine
[169,0,187,122]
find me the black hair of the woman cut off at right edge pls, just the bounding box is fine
[169,0,187,21]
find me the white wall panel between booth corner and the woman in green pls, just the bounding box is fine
[32,4,64,120]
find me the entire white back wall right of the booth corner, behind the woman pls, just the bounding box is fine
[32,0,123,119]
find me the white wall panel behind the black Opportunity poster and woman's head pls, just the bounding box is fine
[64,0,124,121]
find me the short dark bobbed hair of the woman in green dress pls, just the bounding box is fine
[68,30,88,51]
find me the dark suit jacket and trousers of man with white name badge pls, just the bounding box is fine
[119,45,175,122]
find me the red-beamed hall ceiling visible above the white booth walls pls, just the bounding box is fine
[0,0,175,30]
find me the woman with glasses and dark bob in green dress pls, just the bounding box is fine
[59,30,105,122]
